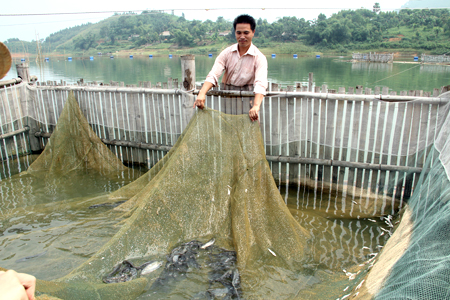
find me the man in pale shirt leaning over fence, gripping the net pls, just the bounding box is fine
[194,15,267,121]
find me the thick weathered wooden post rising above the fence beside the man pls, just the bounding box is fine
[181,54,195,130]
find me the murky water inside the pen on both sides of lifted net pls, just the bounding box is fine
[0,158,391,299]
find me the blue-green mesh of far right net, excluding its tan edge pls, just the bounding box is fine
[376,92,450,299]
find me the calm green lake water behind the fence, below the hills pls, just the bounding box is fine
[3,55,450,92]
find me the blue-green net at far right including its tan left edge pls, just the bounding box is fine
[353,93,450,299]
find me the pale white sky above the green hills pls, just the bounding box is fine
[0,0,408,42]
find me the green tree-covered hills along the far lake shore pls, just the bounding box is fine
[5,9,450,54]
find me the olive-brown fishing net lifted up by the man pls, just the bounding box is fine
[53,103,316,298]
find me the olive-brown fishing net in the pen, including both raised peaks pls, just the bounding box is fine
[0,95,320,299]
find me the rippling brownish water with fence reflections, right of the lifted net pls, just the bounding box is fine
[280,183,391,271]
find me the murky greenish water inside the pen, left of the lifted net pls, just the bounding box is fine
[0,162,142,280]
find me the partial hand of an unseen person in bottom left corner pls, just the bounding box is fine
[0,270,36,300]
